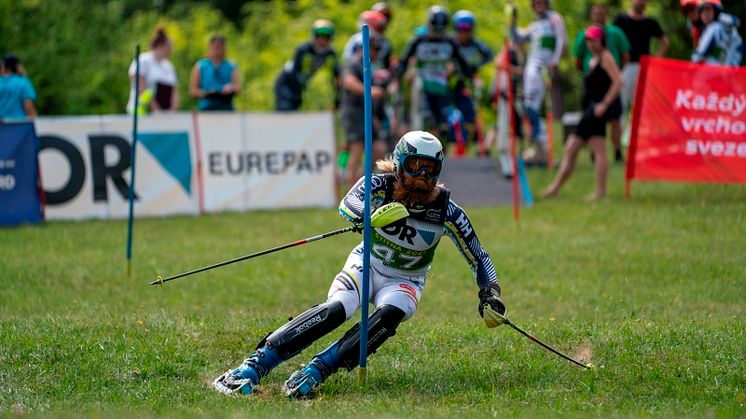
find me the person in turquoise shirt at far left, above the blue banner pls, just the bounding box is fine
[0,54,36,119]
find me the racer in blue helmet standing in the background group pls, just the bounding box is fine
[453,10,494,150]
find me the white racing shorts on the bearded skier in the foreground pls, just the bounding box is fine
[327,245,427,320]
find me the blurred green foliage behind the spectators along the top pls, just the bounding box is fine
[0,0,732,115]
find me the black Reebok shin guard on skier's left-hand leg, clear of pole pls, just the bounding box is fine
[259,301,345,360]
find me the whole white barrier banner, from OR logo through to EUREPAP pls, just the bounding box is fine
[36,112,336,219]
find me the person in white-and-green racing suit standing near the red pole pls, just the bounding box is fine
[510,0,567,163]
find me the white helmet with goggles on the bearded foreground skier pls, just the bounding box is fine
[394,131,444,179]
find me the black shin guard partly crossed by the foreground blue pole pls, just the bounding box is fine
[338,304,405,371]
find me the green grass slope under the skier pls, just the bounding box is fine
[0,162,746,418]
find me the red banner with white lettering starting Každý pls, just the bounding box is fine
[626,57,746,188]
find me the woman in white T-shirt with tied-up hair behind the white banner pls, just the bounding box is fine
[127,27,179,114]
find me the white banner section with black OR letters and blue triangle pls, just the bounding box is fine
[36,113,199,219]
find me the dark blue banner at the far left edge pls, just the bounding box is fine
[0,122,44,225]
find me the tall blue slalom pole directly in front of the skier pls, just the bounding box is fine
[358,25,373,383]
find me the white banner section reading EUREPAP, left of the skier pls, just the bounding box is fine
[198,112,337,212]
